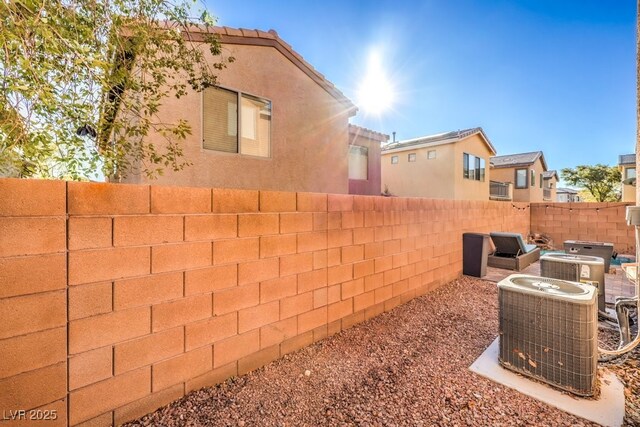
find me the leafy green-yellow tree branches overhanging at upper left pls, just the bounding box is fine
[0,0,233,179]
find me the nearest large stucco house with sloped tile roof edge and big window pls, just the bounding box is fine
[122,27,379,194]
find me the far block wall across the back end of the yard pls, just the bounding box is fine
[531,203,636,255]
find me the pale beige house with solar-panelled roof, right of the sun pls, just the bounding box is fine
[382,127,496,200]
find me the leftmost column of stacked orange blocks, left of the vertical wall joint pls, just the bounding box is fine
[0,179,67,426]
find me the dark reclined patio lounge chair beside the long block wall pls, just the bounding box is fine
[487,232,540,271]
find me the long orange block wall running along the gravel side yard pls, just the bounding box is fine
[0,180,530,426]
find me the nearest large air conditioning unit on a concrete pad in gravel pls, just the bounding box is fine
[498,274,598,396]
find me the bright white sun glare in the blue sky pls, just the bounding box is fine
[358,51,394,115]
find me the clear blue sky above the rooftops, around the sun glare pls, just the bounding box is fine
[206,0,636,178]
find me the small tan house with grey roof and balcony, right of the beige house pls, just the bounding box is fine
[489,151,552,202]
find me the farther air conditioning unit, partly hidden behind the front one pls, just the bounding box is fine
[540,253,605,312]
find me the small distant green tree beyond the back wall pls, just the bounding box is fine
[561,164,622,202]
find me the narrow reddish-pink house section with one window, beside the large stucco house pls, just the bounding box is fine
[349,125,389,196]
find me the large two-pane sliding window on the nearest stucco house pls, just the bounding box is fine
[202,87,271,157]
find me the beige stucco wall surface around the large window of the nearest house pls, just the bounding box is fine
[124,45,349,193]
